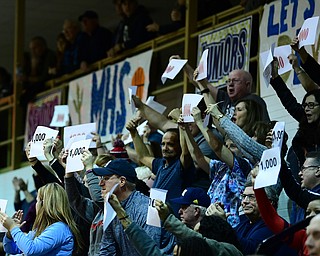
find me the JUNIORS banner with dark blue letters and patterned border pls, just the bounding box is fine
[198,16,252,86]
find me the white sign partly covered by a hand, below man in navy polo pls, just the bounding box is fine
[147,188,167,227]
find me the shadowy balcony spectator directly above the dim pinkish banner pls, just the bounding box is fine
[20,36,57,106]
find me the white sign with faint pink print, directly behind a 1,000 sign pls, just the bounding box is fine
[63,123,96,148]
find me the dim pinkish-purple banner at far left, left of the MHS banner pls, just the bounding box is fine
[25,89,62,145]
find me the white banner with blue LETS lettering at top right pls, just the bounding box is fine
[259,0,320,97]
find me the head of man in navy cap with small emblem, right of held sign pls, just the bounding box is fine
[171,187,210,229]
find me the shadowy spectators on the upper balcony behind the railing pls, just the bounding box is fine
[0,0,272,103]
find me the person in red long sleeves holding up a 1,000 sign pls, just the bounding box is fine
[251,166,320,255]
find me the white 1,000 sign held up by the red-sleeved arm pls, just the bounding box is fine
[254,147,281,189]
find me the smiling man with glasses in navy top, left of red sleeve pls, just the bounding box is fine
[235,179,279,255]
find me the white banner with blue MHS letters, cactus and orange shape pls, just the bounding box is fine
[68,50,152,137]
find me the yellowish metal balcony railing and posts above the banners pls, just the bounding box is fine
[0,4,263,173]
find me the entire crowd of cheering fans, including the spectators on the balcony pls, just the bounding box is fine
[0,0,320,256]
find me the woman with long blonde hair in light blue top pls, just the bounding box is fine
[0,183,82,256]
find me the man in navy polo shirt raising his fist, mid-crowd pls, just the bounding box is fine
[126,119,195,213]
